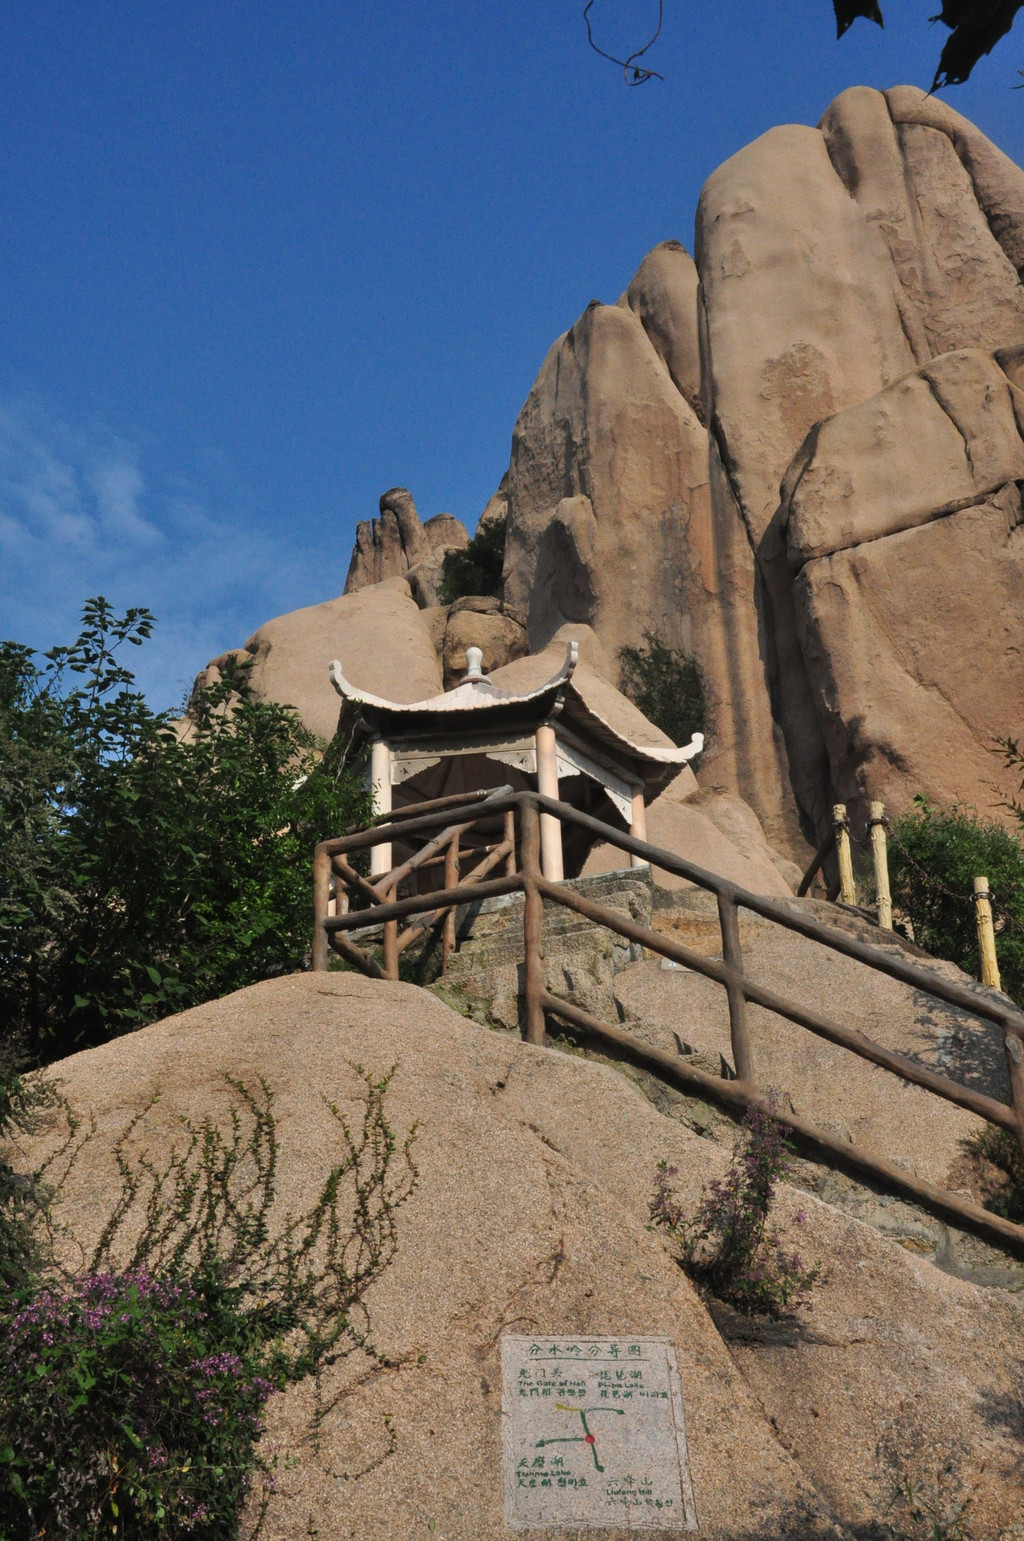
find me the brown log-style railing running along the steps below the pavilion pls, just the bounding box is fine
[314,787,1024,1253]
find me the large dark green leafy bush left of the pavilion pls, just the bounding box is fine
[0,598,368,1059]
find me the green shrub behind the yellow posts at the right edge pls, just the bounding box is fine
[888,798,1024,1002]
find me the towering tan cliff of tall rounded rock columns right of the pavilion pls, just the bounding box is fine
[495,86,1024,863]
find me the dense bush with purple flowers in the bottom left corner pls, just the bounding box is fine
[0,1270,280,1541]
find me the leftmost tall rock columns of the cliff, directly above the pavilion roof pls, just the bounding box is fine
[495,291,708,661]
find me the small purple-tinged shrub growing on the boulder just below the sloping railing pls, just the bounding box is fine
[650,1099,824,1318]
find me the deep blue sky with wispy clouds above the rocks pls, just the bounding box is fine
[0,0,1024,706]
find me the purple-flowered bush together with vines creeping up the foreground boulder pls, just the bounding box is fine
[0,1066,416,1541]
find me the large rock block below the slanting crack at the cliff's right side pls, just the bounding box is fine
[795,484,1024,812]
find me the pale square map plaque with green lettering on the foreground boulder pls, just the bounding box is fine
[502,1333,698,1530]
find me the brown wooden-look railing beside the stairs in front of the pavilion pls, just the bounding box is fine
[313,787,1024,1256]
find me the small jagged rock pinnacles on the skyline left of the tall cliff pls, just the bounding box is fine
[345,487,470,609]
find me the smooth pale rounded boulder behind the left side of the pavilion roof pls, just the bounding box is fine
[196,578,442,740]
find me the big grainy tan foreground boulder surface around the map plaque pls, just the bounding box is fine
[23,974,1024,1541]
